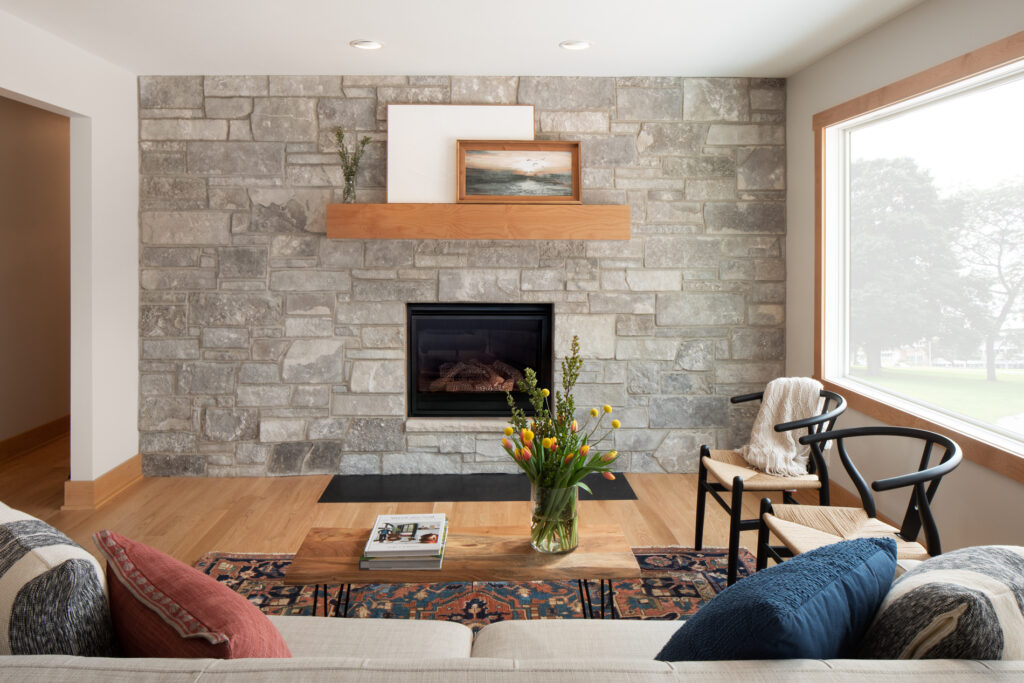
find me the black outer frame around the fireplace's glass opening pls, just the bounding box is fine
[406,303,554,418]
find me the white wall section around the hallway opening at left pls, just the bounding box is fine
[0,10,138,480]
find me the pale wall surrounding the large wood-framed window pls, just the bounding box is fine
[785,0,1024,550]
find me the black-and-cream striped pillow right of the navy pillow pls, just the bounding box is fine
[860,546,1024,659]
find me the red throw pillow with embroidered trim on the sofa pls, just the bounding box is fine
[92,530,292,659]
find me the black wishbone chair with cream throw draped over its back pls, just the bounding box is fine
[694,389,846,586]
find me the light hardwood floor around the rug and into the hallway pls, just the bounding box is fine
[0,438,802,564]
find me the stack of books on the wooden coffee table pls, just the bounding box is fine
[359,513,447,570]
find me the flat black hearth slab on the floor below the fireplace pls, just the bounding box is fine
[317,472,637,503]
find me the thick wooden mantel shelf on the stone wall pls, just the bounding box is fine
[327,204,630,240]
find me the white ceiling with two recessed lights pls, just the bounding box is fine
[0,0,923,77]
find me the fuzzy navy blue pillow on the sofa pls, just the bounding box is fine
[654,539,896,661]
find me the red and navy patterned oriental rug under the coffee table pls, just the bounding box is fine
[196,548,754,631]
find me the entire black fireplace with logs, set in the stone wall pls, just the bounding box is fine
[407,303,553,417]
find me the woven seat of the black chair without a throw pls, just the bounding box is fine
[764,505,930,560]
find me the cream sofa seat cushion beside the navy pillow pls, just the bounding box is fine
[473,618,679,659]
